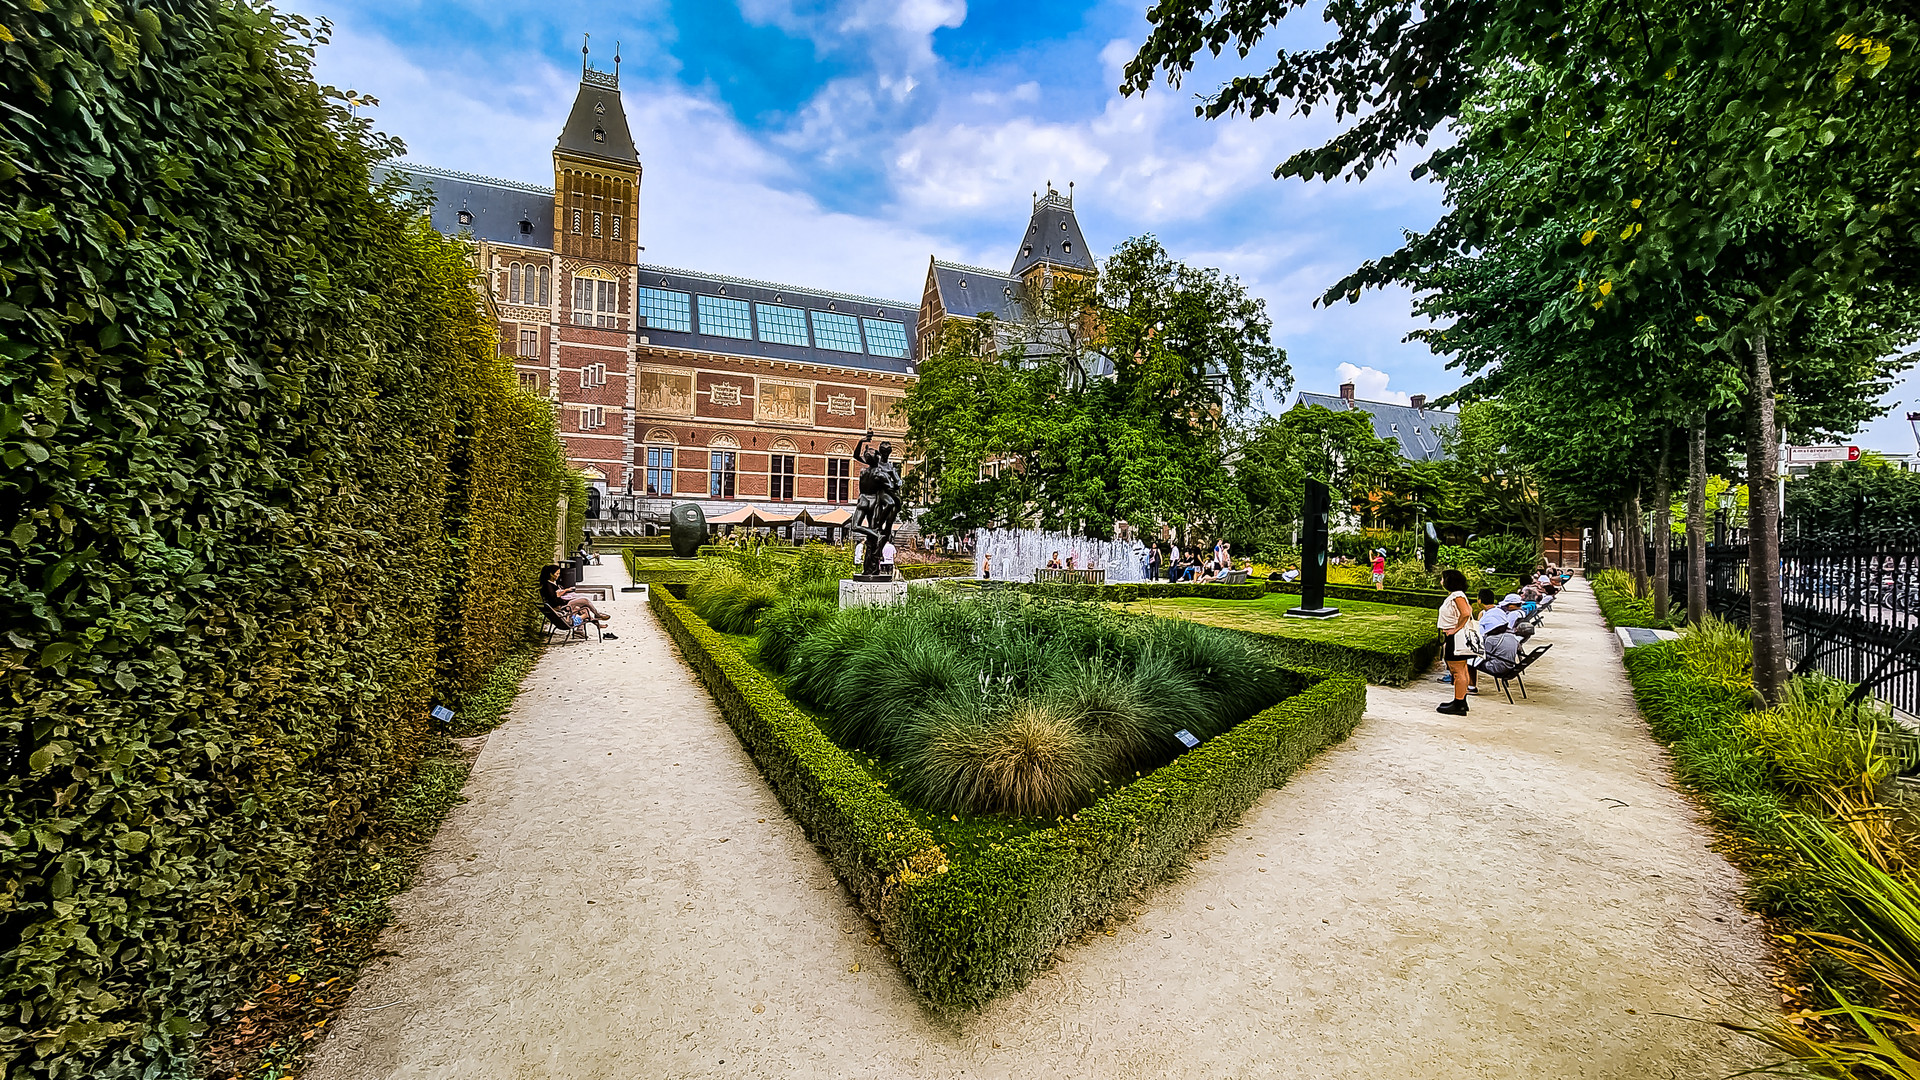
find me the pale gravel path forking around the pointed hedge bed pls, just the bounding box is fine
[305,567,1776,1080]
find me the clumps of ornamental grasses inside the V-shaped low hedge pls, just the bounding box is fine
[762,592,1283,815]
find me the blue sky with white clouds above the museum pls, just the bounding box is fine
[292,0,1920,452]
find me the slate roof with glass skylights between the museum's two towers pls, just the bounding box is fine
[637,263,920,375]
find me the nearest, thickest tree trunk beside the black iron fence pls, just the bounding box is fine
[1747,331,1791,703]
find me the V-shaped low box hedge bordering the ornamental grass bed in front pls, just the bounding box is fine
[649,590,1367,1013]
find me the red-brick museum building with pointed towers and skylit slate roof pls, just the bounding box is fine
[394,55,1094,519]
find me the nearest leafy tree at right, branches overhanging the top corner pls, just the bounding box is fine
[1123,0,1920,700]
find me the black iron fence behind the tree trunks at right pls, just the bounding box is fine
[1647,538,1920,715]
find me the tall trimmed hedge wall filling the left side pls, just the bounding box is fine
[0,0,561,1080]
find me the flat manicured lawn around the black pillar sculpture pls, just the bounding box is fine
[1116,592,1440,686]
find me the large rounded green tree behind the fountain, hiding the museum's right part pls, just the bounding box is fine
[906,236,1290,532]
